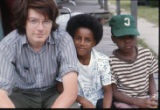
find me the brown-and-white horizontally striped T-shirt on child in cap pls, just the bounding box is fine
[110,47,158,98]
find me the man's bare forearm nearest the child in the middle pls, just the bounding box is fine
[51,72,78,108]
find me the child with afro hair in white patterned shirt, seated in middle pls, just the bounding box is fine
[57,14,112,108]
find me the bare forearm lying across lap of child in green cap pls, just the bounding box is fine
[112,84,156,108]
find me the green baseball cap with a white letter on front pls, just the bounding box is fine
[109,15,139,37]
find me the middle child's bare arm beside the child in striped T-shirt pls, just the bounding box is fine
[103,85,112,108]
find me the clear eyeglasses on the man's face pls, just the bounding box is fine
[28,17,52,27]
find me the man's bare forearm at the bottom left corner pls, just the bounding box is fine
[0,89,15,108]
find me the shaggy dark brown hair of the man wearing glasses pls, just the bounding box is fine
[13,0,58,34]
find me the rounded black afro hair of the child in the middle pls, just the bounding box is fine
[66,14,103,45]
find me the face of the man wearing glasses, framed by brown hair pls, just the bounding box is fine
[26,9,52,46]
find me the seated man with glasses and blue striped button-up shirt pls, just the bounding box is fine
[0,0,78,108]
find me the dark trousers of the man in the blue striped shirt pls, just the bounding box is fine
[9,88,59,108]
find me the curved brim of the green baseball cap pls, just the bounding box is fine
[112,28,140,37]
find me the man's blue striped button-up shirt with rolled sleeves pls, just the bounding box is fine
[0,30,78,92]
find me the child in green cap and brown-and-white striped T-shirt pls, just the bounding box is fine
[109,15,158,108]
